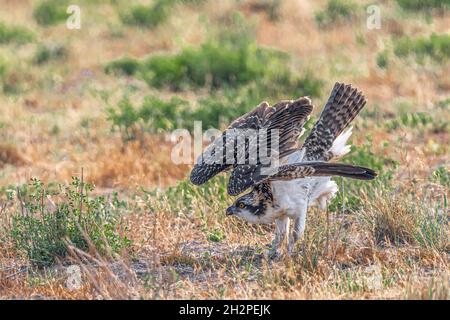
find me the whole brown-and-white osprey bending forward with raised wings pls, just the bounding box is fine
[190,83,376,255]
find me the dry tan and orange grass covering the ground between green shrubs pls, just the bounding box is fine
[0,0,450,299]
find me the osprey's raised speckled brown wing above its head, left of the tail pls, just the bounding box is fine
[190,97,313,195]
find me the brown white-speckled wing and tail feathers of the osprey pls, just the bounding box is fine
[190,83,374,195]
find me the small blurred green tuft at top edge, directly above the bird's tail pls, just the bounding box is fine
[314,0,358,28]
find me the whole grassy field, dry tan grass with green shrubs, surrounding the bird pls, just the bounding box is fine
[0,0,450,299]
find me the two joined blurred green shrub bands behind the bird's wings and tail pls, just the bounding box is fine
[105,16,324,135]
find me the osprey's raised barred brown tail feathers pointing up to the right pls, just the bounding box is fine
[302,83,366,161]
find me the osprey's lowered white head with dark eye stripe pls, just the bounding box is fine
[226,190,266,223]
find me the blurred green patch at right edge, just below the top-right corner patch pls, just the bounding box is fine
[394,33,450,63]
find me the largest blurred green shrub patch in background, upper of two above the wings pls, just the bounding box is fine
[105,16,320,95]
